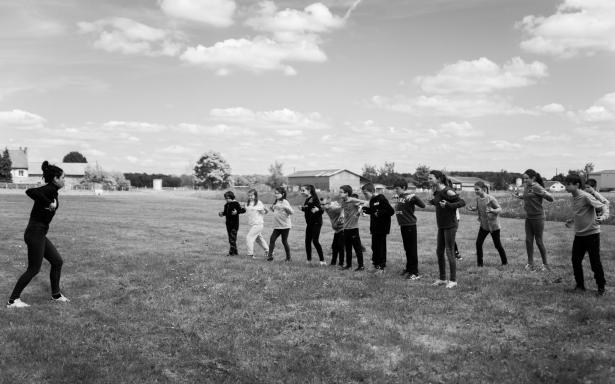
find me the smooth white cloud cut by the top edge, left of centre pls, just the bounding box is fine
[159,0,237,27]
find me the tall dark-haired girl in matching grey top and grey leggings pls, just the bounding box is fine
[513,169,553,271]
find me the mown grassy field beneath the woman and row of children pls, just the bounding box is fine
[0,193,615,383]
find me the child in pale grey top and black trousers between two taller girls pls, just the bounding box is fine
[468,181,508,267]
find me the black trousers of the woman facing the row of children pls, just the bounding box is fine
[11,223,63,300]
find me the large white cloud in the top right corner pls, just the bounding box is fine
[517,0,615,58]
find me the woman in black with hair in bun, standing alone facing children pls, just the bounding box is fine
[6,161,69,308]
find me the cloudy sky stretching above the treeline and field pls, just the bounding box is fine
[0,0,615,177]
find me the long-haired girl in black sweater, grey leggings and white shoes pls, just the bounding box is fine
[428,170,466,288]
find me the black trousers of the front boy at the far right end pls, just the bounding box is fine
[572,233,606,288]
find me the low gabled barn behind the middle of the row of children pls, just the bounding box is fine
[288,169,368,192]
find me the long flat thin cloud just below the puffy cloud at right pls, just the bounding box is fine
[371,95,535,119]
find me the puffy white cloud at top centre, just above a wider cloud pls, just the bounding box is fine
[246,1,345,42]
